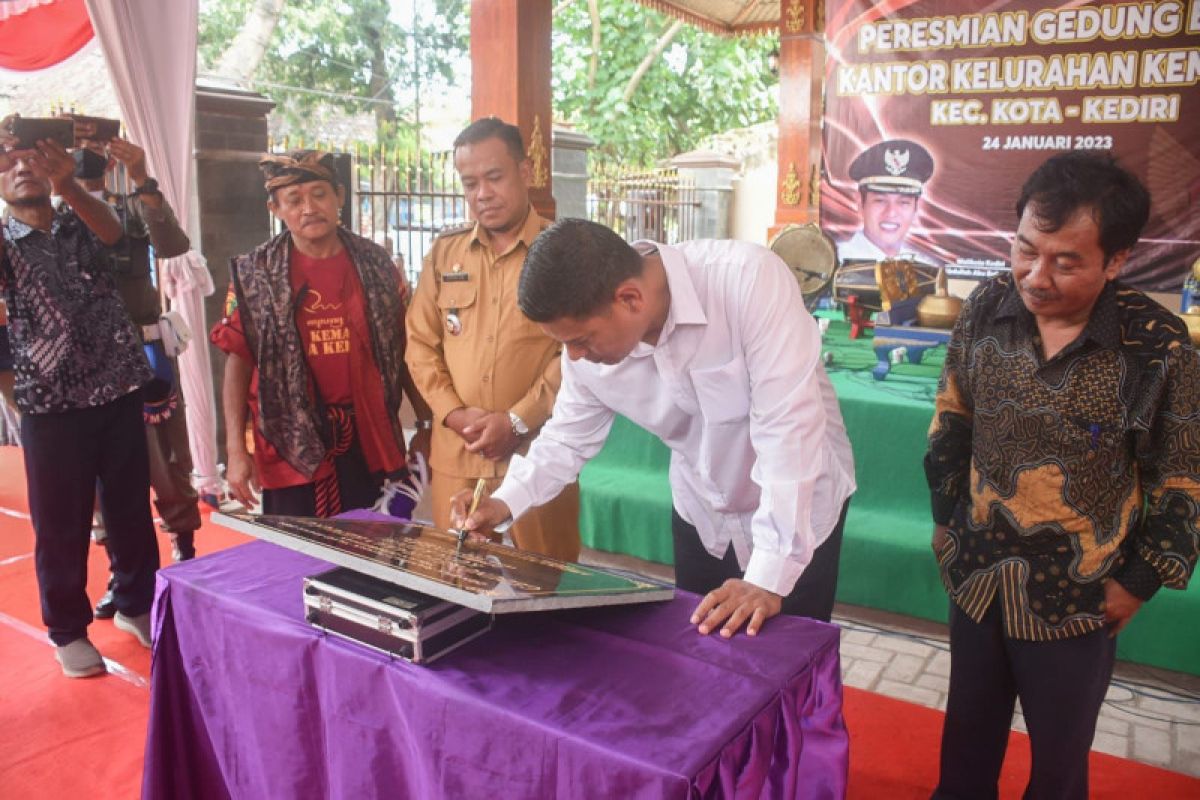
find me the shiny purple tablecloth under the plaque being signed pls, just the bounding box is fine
[143,542,848,800]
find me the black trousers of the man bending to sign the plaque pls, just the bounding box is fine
[671,500,850,622]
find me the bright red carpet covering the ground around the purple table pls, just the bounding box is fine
[0,447,1200,800]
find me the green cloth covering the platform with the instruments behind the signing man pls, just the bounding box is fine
[580,321,1200,674]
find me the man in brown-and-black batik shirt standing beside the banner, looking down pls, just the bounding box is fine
[925,152,1200,799]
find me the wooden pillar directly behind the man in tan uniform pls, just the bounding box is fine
[470,0,554,219]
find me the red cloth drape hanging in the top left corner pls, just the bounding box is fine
[0,0,92,71]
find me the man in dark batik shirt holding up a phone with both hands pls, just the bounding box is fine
[0,122,158,678]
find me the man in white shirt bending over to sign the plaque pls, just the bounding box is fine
[454,219,854,637]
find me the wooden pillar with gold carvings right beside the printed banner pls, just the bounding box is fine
[770,0,824,236]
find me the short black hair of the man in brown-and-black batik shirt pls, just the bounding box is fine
[1016,150,1150,261]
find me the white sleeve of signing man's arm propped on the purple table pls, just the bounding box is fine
[739,254,829,595]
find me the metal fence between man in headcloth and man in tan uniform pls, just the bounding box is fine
[271,144,467,287]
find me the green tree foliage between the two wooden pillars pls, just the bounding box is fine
[553,0,779,163]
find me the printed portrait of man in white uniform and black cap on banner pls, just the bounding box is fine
[838,139,940,266]
